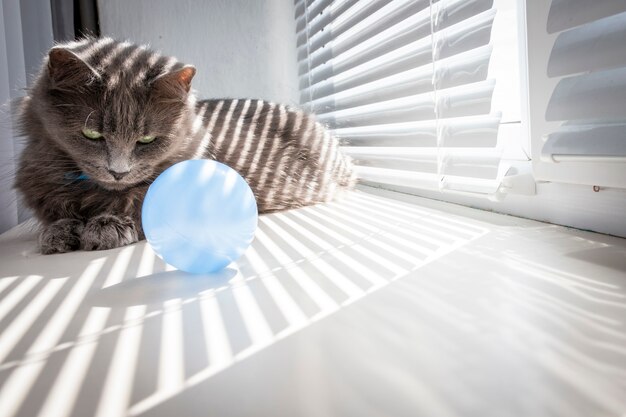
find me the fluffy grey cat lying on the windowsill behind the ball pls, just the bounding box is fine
[16,38,354,253]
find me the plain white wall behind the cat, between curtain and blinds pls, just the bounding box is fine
[98,0,299,105]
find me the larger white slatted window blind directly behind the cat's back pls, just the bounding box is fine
[295,0,520,196]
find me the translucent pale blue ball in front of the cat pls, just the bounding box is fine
[141,160,258,274]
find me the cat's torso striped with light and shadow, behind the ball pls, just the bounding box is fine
[192,99,354,212]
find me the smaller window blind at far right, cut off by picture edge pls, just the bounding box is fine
[527,0,626,188]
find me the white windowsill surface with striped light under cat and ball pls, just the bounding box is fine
[0,187,626,417]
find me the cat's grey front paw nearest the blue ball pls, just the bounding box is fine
[80,214,138,250]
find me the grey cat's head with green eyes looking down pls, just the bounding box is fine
[30,39,195,190]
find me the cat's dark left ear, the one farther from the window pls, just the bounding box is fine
[48,48,99,88]
